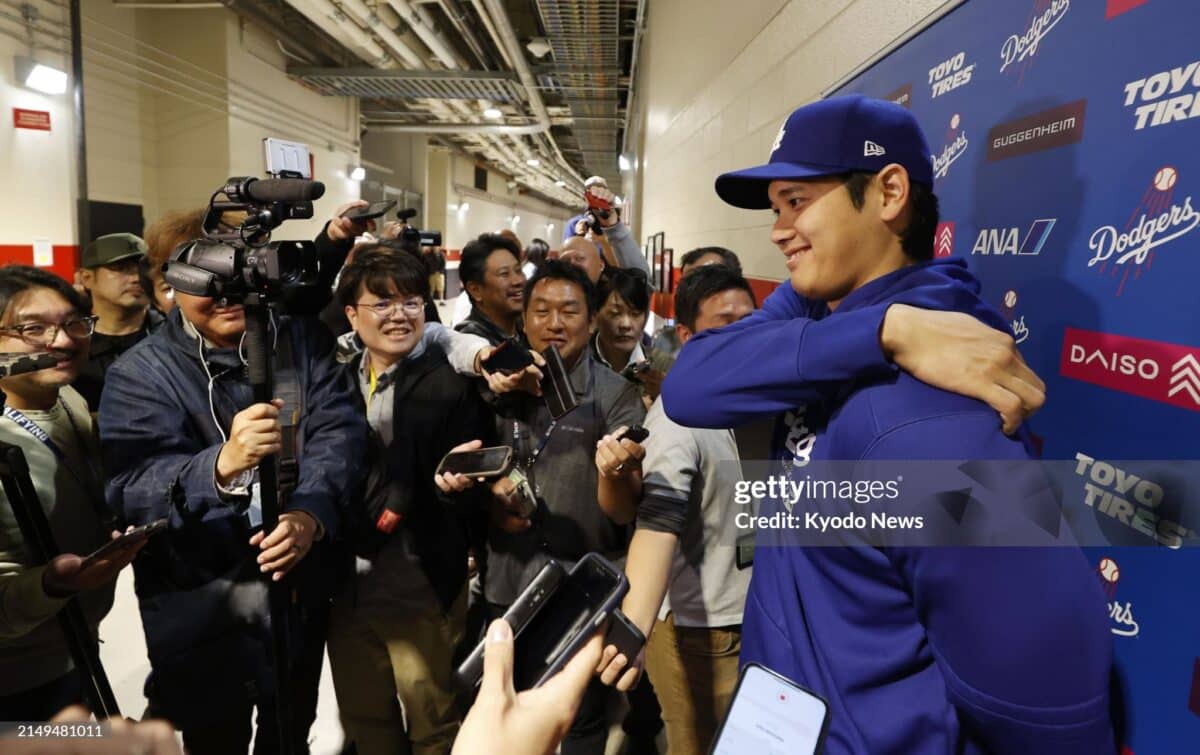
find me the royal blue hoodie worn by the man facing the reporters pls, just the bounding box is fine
[662,260,1115,755]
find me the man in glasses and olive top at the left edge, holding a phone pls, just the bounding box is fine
[0,265,140,721]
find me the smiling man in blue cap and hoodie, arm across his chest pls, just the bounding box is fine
[664,96,1114,754]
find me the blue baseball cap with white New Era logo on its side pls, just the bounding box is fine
[716,95,934,210]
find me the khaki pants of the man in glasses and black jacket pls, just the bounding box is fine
[329,591,467,755]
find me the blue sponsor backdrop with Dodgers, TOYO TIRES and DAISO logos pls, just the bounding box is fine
[835,0,1200,755]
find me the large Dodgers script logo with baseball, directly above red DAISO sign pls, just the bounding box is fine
[1087,166,1200,296]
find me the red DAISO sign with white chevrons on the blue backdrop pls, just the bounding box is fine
[1058,328,1200,412]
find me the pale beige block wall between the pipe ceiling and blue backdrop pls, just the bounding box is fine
[629,0,943,280]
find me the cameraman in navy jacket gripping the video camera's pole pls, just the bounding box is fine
[100,246,366,755]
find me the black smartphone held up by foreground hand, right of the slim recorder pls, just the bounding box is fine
[512,558,628,690]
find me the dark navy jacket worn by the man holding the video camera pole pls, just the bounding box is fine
[100,310,366,710]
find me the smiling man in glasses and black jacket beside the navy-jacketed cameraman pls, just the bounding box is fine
[329,245,494,755]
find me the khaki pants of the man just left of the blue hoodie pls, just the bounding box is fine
[646,613,742,755]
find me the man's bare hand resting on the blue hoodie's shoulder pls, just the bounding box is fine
[880,304,1046,435]
